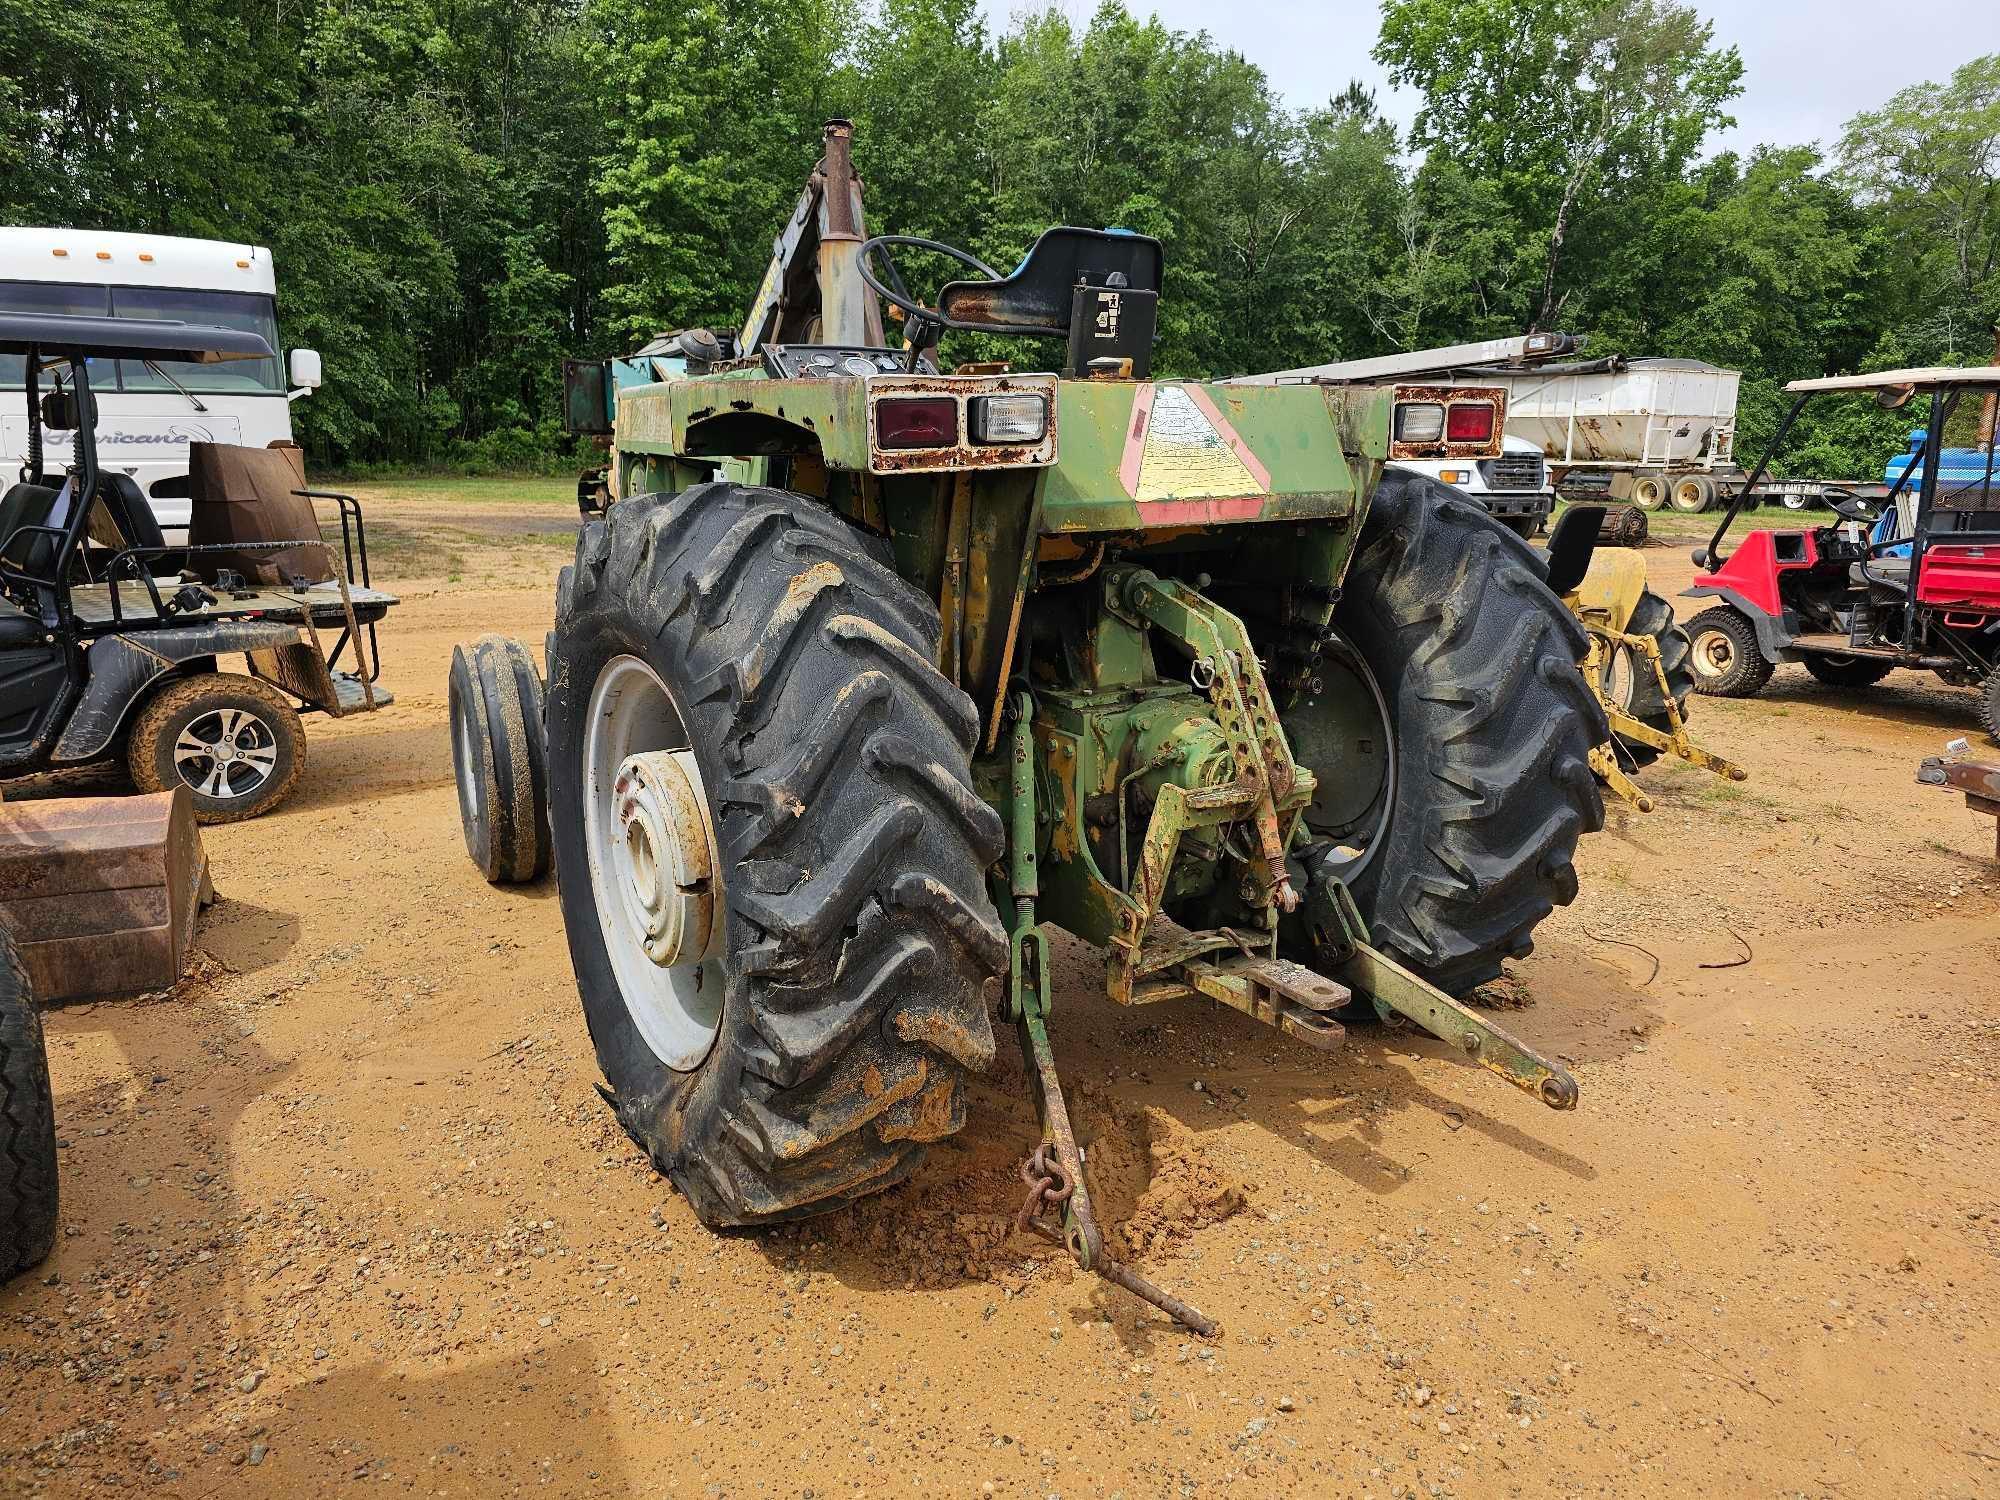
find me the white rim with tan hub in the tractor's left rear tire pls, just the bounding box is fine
[584,656,726,1072]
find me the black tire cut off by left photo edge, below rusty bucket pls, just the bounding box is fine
[0,930,58,1282]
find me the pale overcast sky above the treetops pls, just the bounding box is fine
[982,0,2000,150]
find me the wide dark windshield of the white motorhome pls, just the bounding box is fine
[0,282,284,396]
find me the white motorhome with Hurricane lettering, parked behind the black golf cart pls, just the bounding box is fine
[0,228,320,544]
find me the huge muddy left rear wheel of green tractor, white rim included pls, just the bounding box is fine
[548,482,1008,1226]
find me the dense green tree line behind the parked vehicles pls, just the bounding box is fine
[0,0,2000,472]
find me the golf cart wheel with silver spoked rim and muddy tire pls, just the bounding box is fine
[126,672,306,824]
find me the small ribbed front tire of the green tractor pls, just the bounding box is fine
[446,636,550,886]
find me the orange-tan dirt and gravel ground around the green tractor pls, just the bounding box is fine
[0,486,2000,1500]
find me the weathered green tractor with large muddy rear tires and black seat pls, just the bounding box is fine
[452,122,1606,1328]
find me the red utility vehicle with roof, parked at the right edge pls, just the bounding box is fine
[1686,368,2000,740]
